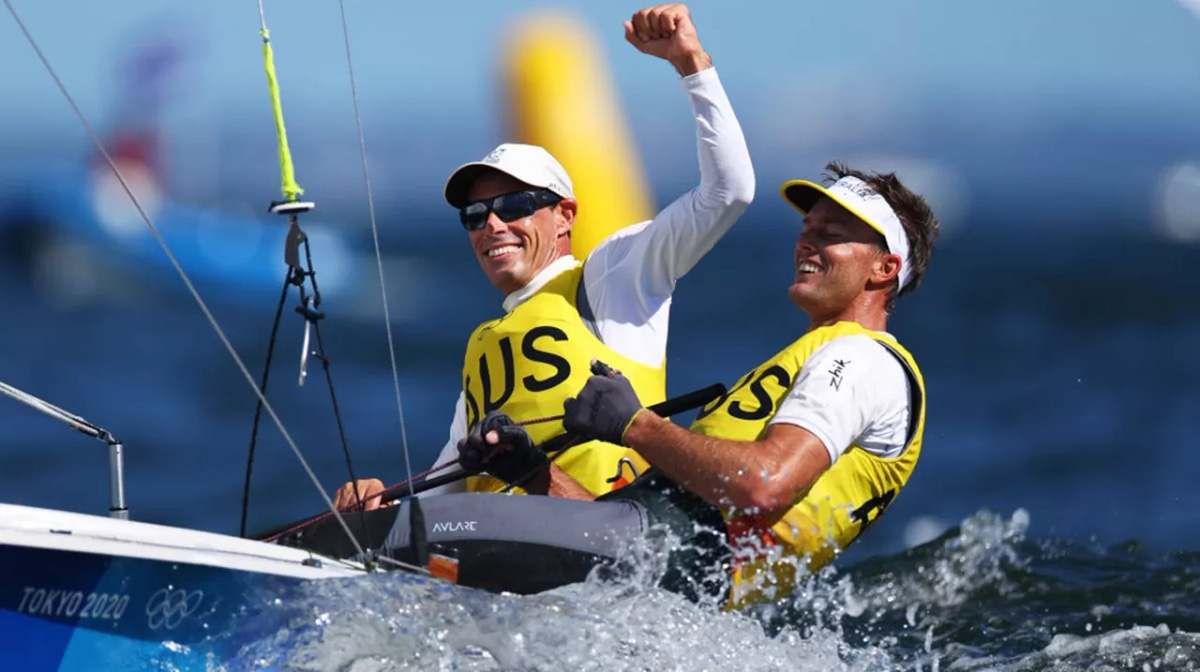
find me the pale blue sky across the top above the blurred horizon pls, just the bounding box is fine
[0,0,1200,118]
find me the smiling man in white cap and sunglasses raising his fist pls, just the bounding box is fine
[337,4,755,509]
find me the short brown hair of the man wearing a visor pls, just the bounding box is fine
[826,161,940,312]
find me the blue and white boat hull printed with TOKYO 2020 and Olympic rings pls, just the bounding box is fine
[0,505,364,670]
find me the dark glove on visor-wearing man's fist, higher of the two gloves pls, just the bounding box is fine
[563,361,642,445]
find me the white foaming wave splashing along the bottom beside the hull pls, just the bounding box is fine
[150,510,1200,672]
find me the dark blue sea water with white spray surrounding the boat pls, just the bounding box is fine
[0,220,1200,671]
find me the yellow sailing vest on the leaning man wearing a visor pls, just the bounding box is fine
[691,322,925,608]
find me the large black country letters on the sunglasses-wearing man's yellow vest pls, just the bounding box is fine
[463,325,571,427]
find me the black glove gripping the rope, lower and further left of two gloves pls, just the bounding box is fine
[458,410,550,484]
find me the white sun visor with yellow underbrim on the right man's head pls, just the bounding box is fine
[779,175,912,289]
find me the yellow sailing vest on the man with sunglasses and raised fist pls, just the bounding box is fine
[462,262,666,494]
